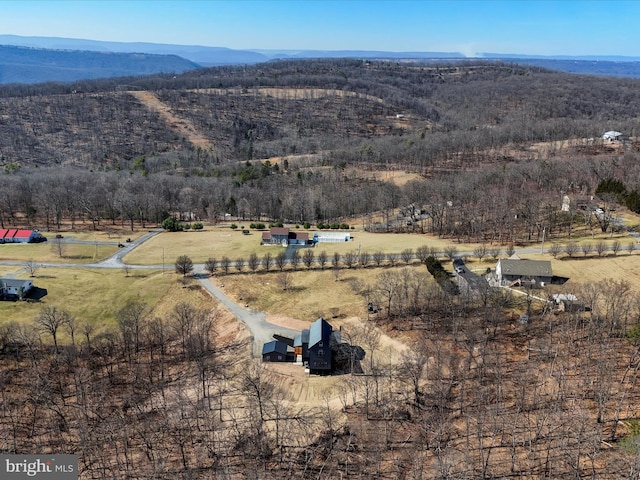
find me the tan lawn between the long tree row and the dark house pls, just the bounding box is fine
[211,263,433,322]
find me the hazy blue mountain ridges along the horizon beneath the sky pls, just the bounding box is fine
[0,35,640,84]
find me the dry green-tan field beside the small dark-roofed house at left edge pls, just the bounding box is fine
[0,268,175,330]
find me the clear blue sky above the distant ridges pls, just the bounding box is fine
[0,0,640,56]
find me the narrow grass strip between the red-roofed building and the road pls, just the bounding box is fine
[0,242,118,263]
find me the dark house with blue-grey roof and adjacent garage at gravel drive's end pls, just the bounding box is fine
[262,318,364,375]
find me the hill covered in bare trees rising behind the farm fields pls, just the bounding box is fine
[0,60,640,242]
